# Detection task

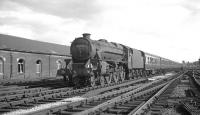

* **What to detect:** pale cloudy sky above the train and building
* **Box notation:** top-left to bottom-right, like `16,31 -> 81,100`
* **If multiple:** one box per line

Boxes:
0,0 -> 200,62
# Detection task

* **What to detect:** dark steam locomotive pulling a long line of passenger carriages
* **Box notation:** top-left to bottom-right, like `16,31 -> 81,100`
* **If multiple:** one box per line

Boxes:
58,33 -> 182,87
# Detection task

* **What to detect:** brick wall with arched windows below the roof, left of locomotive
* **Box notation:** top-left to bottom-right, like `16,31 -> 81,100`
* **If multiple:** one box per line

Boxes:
0,50 -> 69,80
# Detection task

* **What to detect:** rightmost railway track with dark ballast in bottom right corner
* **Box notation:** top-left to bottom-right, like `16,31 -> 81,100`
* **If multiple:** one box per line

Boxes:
144,72 -> 200,115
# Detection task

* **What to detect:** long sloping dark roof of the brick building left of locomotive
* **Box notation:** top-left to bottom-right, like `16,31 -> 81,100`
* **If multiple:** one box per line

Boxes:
0,34 -> 70,55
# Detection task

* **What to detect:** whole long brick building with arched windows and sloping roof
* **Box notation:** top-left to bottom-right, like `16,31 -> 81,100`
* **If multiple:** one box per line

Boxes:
0,34 -> 70,81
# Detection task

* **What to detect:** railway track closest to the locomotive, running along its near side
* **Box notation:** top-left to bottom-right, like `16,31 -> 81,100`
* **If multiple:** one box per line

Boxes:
0,78 -> 150,113
